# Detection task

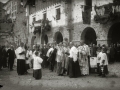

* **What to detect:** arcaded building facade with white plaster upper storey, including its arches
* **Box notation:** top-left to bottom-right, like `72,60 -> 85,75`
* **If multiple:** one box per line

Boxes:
26,0 -> 120,45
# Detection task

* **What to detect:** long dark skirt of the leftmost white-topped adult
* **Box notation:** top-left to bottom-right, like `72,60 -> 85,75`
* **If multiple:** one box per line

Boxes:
17,59 -> 26,75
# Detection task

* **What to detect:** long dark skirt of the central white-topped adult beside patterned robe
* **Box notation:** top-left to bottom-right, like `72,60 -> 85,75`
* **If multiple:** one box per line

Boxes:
68,58 -> 80,78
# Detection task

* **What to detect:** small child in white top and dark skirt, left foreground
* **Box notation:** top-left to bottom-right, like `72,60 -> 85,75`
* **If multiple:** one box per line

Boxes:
33,51 -> 43,80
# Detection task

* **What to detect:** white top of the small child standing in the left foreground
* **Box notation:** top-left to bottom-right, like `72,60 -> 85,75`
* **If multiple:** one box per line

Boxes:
33,56 -> 43,70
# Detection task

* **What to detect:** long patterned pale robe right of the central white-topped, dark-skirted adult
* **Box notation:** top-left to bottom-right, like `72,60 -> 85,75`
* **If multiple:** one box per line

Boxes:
78,46 -> 89,75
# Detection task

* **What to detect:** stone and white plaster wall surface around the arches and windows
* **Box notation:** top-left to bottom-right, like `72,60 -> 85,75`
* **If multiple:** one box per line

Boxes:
29,0 -> 117,45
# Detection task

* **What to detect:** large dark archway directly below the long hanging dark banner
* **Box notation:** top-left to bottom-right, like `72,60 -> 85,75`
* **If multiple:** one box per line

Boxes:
81,27 -> 97,45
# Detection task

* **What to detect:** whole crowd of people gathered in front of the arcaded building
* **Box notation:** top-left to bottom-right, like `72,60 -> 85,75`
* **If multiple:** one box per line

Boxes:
0,40 -> 120,79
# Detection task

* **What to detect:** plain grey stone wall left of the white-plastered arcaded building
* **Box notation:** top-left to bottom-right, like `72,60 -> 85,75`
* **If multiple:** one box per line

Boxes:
14,6 -> 28,43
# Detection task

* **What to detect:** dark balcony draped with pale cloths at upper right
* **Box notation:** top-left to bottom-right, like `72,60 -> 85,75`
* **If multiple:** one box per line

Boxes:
94,3 -> 120,24
